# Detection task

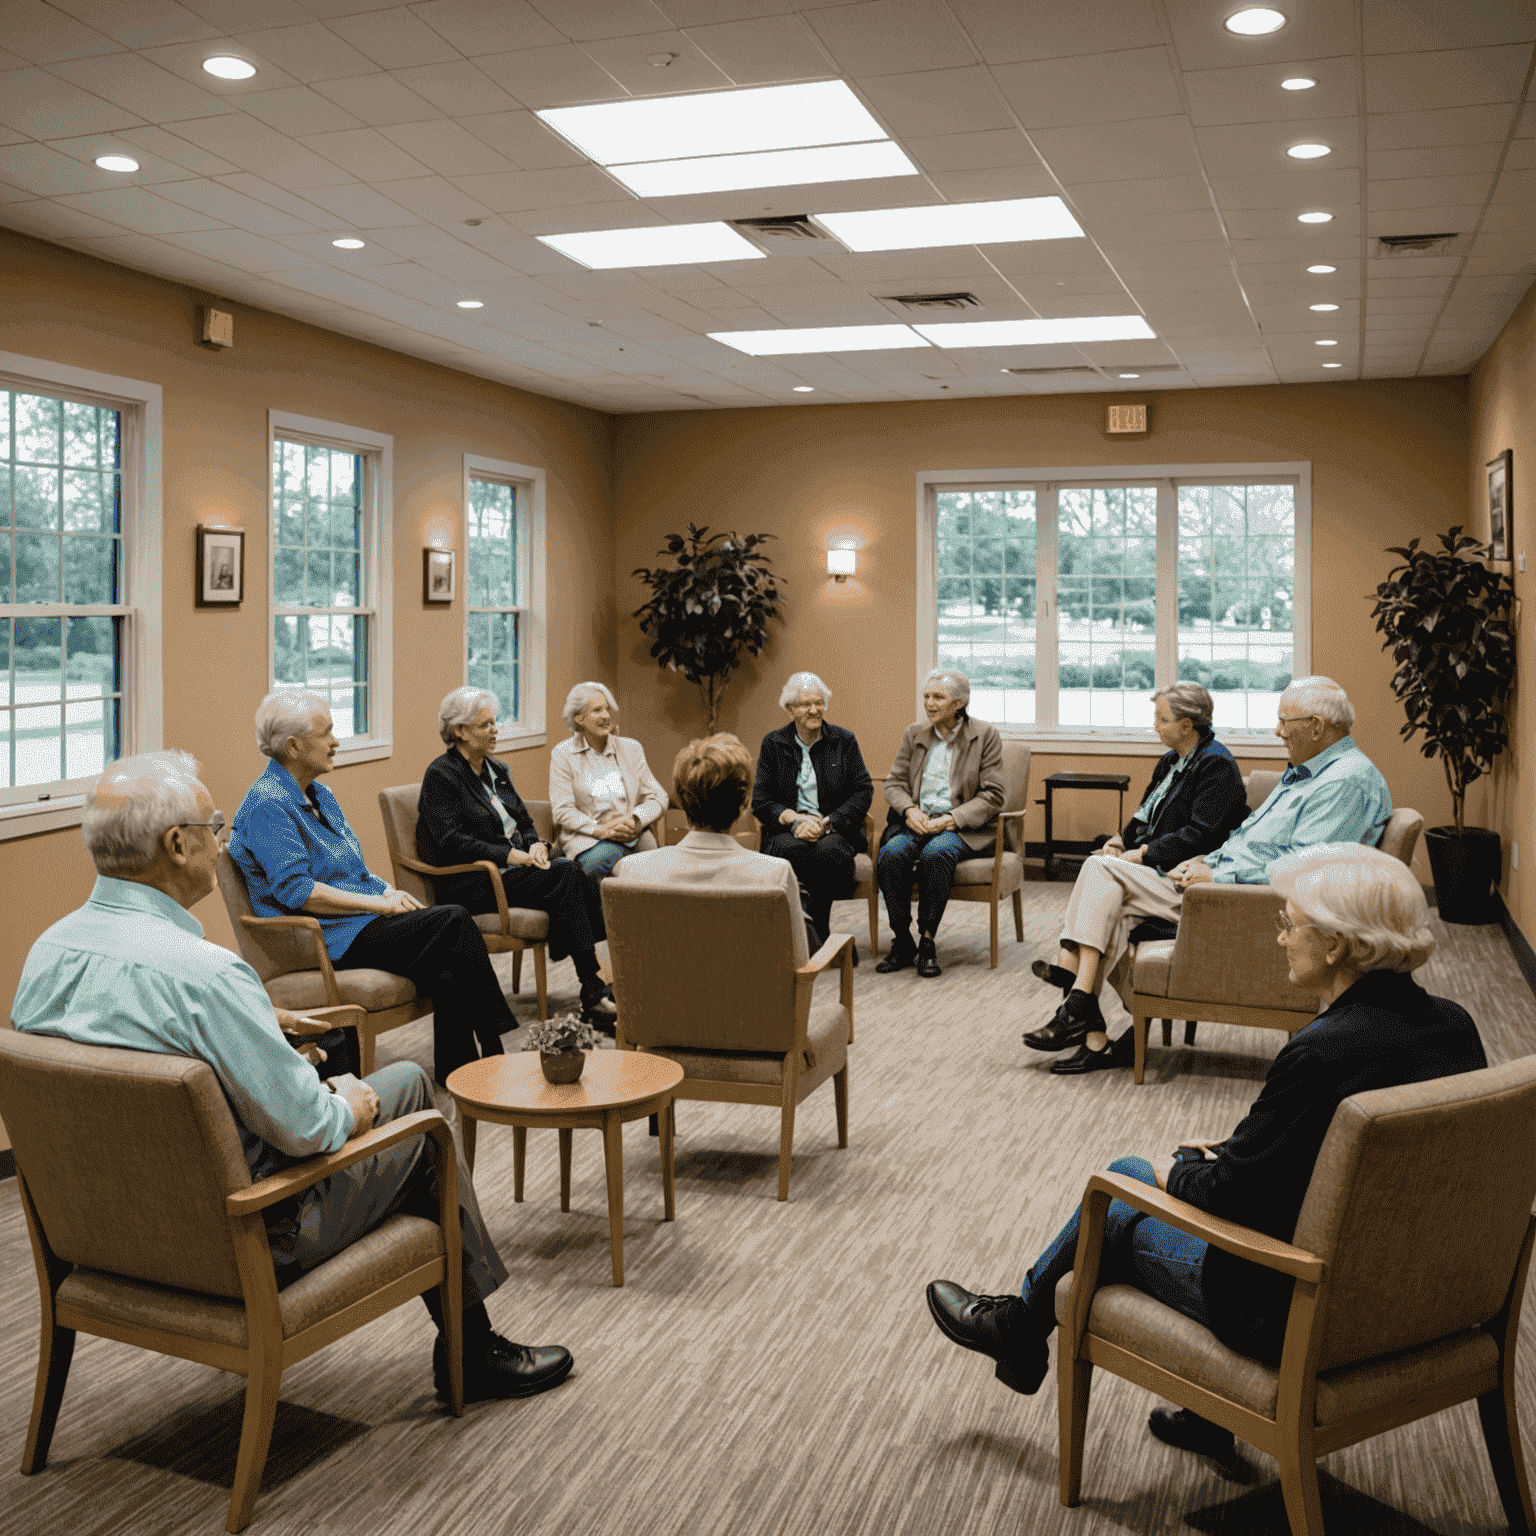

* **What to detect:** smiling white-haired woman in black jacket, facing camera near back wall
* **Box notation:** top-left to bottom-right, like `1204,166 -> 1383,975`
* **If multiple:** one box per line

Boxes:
753,671 -> 874,946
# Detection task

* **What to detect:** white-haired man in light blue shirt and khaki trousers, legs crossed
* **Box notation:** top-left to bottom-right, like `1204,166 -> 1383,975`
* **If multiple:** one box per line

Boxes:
1025,677 -> 1392,1074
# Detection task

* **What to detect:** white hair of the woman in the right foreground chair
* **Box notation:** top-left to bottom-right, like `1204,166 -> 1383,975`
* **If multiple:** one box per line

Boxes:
1269,843 -> 1435,971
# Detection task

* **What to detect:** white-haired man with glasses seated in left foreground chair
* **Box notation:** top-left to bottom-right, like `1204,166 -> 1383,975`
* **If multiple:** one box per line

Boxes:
11,751 -> 571,1401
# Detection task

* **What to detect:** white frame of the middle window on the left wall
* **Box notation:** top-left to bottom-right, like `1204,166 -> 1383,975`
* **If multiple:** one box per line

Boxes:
267,410 -> 395,768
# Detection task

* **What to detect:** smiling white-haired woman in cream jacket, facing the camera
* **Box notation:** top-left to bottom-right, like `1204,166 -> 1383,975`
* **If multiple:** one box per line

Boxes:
550,682 -> 667,886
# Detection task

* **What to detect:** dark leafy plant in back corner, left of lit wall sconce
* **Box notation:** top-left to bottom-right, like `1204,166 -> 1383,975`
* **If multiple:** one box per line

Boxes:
631,522 -> 779,734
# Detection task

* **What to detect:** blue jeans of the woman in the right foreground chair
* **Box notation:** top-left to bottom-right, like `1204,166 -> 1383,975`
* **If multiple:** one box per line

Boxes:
1020,1157 -> 1210,1329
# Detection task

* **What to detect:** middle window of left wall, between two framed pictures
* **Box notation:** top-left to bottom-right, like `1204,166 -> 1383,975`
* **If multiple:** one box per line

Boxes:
270,412 -> 393,763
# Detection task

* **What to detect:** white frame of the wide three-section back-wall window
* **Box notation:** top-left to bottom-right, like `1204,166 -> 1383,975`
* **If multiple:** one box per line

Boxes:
914,461 -> 1312,757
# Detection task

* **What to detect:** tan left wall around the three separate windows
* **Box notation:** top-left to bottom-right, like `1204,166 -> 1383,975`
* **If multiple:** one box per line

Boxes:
0,230 -> 614,1003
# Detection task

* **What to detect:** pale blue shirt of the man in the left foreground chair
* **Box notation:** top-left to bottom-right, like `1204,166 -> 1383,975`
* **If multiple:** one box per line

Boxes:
11,876 -> 353,1178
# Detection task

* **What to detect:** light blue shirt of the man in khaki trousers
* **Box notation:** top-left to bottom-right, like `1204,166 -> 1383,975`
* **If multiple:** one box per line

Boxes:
1206,736 -> 1392,885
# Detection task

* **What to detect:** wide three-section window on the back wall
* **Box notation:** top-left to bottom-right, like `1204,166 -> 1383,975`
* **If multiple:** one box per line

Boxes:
919,464 -> 1310,751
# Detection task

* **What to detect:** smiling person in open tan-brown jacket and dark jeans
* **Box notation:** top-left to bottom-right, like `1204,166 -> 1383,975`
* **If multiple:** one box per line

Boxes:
876,667 -> 1006,977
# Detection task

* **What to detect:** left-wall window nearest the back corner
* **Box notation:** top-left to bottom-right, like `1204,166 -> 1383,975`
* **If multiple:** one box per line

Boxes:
464,453 -> 544,746
